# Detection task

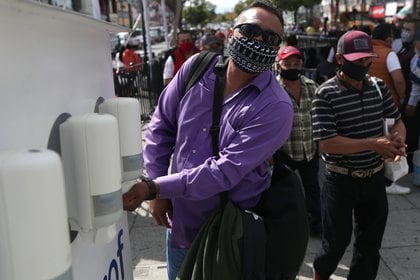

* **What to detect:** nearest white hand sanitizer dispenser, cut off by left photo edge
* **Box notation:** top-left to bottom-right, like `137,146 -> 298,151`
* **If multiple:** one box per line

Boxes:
0,150 -> 73,280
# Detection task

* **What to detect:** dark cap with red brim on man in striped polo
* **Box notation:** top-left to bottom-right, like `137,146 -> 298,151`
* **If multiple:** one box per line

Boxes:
337,30 -> 377,61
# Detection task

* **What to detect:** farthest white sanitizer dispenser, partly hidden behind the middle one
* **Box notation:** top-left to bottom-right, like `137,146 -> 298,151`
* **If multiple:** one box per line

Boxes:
99,97 -> 143,192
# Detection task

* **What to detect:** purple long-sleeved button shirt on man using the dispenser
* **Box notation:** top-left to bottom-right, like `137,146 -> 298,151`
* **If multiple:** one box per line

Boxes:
144,54 -> 293,248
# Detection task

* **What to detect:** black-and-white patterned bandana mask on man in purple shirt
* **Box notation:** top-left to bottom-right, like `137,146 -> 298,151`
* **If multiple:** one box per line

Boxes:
228,36 -> 277,73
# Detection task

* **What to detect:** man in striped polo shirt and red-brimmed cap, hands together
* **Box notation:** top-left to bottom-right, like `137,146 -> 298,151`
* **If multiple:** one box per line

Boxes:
312,30 -> 406,280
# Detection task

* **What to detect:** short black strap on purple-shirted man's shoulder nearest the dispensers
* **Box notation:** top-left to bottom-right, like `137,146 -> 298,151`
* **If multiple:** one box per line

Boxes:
183,51 -> 218,94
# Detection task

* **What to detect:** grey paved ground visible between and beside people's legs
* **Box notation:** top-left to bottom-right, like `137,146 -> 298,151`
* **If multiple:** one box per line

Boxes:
129,123 -> 420,280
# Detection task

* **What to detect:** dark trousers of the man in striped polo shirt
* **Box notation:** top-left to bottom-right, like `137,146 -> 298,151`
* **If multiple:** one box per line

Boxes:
314,171 -> 388,280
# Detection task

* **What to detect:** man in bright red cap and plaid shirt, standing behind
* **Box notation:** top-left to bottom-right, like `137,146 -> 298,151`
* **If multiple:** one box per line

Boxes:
277,46 -> 322,237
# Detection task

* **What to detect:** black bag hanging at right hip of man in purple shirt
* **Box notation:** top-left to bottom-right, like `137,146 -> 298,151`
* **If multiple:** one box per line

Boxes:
253,151 -> 309,280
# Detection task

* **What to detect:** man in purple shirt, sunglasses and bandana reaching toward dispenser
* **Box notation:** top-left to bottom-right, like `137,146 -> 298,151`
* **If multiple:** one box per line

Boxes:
123,1 -> 293,280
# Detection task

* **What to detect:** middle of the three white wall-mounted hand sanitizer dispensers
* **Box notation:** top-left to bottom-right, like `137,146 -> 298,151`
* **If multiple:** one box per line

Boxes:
60,113 -> 123,243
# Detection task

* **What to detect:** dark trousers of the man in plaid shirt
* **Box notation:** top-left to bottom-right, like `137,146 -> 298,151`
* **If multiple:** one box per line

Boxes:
296,154 -> 321,232
